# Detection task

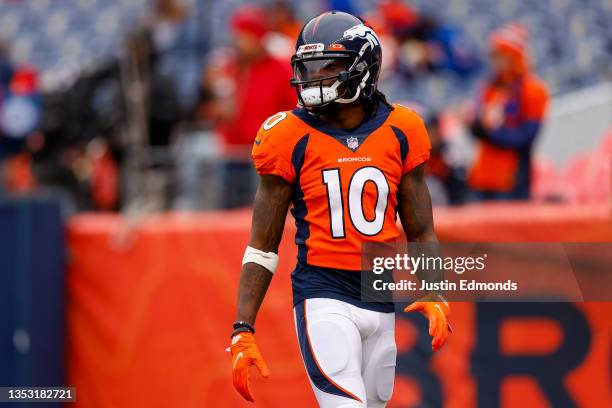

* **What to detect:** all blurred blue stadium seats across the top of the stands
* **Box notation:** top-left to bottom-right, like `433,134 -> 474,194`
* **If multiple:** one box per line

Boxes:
0,0 -> 612,103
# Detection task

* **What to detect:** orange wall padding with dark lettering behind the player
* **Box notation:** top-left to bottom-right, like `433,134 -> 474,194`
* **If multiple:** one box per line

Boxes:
67,204 -> 612,408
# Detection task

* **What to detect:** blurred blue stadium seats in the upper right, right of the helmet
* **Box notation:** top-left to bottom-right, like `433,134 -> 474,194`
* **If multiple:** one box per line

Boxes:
382,0 -> 612,108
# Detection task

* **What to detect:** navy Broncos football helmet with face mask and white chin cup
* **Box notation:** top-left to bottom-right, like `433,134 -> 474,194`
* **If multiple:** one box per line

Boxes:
291,11 -> 382,109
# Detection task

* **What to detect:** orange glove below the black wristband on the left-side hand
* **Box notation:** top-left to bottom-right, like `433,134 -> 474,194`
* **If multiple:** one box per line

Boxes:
229,332 -> 270,402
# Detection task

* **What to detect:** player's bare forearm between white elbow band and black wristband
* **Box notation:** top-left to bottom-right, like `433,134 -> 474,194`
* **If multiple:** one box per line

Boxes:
236,263 -> 273,324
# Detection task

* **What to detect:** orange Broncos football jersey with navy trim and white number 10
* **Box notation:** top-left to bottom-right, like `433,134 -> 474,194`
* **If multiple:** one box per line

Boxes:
252,103 -> 431,271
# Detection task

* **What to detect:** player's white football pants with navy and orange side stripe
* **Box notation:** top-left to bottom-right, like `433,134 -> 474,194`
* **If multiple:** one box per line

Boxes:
294,298 -> 397,408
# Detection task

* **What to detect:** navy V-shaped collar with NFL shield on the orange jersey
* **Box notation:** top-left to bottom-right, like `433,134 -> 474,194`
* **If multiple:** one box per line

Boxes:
293,102 -> 391,151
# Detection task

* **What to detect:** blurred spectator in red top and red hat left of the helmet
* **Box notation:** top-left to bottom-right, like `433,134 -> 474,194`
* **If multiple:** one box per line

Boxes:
200,6 -> 296,208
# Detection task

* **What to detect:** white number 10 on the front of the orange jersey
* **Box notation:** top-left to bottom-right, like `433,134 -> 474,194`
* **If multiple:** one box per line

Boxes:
322,167 -> 389,238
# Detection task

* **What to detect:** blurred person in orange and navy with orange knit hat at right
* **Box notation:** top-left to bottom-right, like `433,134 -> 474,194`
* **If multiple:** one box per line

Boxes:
469,24 -> 548,200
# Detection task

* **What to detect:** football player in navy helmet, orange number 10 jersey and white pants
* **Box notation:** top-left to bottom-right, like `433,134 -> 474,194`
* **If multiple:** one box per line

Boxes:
230,11 -> 450,408
